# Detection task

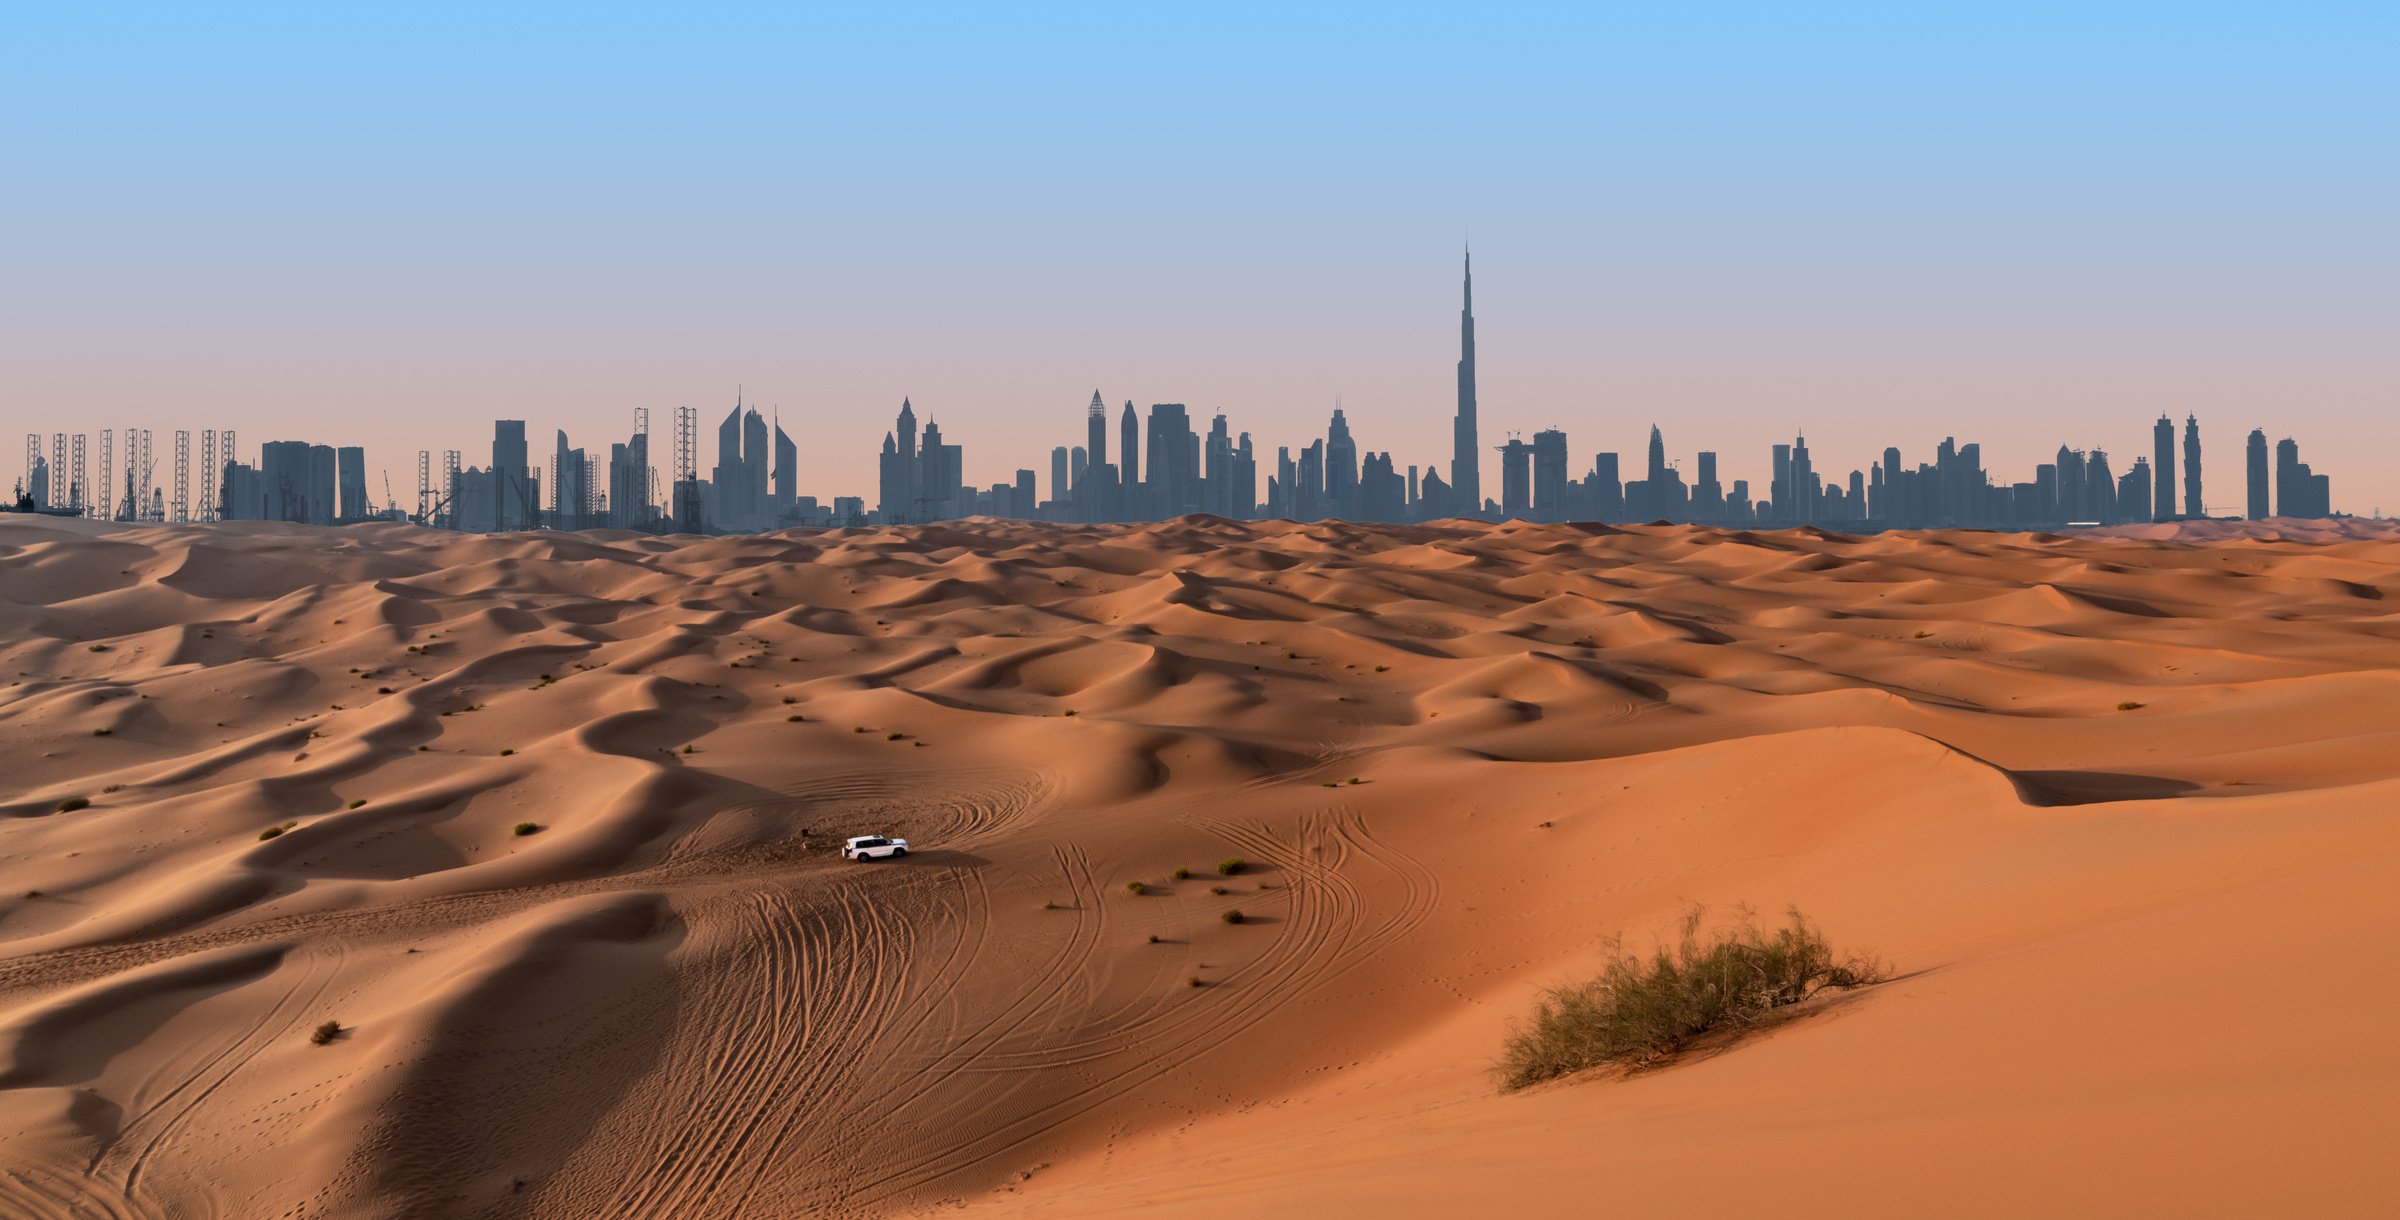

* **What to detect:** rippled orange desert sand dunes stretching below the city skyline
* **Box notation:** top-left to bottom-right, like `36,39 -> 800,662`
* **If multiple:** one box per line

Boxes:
0,516 -> 2400,1218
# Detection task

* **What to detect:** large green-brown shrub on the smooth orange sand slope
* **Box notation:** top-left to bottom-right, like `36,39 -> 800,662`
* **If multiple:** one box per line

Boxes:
1498,910 -> 1884,1088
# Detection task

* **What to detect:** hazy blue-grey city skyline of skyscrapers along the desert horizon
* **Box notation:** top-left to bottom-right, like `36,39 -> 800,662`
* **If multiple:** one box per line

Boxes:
17,249 -> 2361,533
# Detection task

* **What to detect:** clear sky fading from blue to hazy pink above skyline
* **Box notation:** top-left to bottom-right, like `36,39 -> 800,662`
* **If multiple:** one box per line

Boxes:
0,0 -> 2400,514
